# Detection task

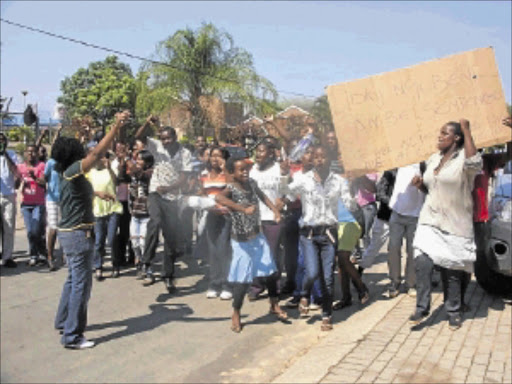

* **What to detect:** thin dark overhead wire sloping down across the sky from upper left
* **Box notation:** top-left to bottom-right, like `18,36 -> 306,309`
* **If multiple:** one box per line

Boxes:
0,18 -> 318,99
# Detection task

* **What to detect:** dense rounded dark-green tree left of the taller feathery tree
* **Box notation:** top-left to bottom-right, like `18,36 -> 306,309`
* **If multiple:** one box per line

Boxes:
58,56 -> 136,126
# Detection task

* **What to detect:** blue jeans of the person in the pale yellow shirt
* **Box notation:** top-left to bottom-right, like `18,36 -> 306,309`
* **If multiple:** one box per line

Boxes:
94,213 -> 120,269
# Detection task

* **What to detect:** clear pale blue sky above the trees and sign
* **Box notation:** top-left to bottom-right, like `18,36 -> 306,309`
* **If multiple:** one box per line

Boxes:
0,0 -> 512,118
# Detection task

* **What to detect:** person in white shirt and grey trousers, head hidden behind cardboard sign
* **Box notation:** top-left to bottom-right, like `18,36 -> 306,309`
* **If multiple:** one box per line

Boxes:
388,164 -> 425,298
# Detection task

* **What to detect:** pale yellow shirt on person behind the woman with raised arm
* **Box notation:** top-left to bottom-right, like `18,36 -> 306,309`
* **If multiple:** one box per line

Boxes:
86,168 -> 123,217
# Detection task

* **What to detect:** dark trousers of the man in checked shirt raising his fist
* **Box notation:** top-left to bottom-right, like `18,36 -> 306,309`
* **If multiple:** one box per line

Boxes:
142,192 -> 180,278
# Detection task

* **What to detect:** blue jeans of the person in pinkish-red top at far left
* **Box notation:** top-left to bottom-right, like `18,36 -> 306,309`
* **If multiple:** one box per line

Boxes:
21,204 -> 46,257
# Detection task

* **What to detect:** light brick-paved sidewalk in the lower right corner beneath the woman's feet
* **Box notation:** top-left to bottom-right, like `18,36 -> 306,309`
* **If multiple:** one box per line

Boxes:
320,281 -> 512,383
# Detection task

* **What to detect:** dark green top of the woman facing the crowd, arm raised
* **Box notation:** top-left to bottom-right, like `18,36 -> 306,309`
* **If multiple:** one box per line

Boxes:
59,161 -> 94,231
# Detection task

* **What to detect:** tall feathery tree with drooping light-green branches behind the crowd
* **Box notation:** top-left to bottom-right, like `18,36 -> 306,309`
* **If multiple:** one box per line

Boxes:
138,23 -> 277,133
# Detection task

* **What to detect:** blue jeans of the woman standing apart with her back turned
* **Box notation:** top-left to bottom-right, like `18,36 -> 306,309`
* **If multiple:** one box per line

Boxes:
55,230 -> 93,345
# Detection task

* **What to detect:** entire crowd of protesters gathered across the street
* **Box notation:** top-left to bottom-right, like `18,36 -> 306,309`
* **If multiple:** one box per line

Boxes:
0,111 -> 510,349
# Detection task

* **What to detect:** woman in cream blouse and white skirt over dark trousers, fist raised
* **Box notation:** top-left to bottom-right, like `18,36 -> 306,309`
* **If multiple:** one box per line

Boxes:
409,119 -> 482,330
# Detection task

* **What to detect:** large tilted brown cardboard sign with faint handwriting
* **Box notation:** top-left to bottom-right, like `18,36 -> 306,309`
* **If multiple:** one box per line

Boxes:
327,48 -> 511,174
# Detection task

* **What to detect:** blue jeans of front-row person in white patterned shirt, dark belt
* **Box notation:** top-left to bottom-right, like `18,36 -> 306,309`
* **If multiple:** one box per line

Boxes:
300,234 -> 336,317
